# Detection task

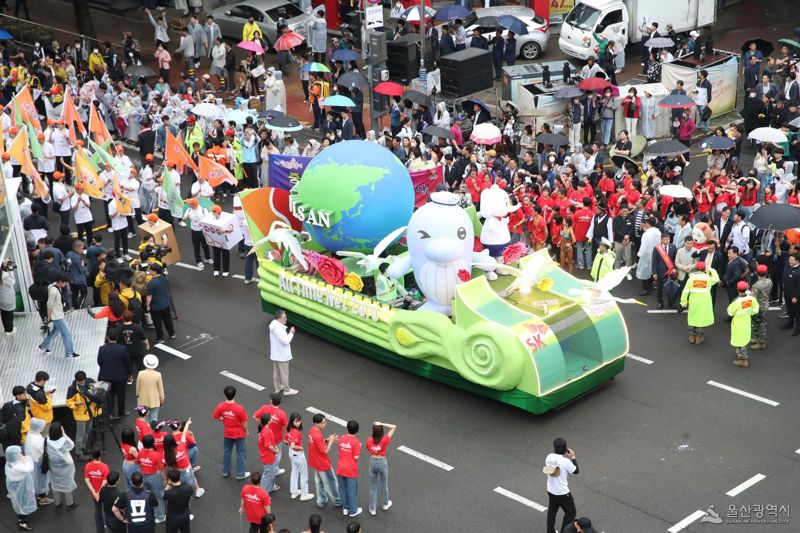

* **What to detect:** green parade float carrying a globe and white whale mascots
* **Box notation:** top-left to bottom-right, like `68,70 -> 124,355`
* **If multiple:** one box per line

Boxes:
240,141 -> 628,414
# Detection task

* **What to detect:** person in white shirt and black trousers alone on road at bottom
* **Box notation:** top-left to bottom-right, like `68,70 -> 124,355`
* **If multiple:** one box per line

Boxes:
542,437 -> 578,533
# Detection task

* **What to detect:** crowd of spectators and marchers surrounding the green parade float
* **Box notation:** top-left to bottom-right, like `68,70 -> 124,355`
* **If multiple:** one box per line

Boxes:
0,1 -> 800,533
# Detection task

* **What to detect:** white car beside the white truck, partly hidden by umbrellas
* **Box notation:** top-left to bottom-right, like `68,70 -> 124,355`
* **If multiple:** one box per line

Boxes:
464,6 -> 550,59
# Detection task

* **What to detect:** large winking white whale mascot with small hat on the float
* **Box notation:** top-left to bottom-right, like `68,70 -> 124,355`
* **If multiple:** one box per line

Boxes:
386,191 -> 494,316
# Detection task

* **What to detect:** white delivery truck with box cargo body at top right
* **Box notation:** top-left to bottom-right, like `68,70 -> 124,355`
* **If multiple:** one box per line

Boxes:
558,0 -> 717,59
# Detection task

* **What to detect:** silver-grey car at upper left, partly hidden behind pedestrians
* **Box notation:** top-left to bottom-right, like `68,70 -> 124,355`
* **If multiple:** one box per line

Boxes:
211,0 -> 311,43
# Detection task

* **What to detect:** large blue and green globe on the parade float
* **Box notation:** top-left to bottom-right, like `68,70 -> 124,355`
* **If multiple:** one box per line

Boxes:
290,141 -> 414,252
